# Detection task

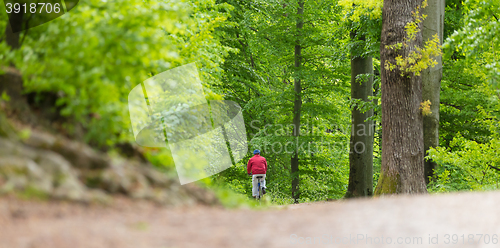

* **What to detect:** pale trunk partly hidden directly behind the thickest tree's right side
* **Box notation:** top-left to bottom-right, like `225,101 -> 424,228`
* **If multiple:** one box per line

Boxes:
422,0 -> 445,183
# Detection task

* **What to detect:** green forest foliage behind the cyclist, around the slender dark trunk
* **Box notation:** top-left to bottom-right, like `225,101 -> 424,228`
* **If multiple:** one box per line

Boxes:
212,0 -> 350,204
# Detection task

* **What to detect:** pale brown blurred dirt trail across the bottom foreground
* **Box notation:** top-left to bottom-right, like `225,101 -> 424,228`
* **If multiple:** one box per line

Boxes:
0,192 -> 500,248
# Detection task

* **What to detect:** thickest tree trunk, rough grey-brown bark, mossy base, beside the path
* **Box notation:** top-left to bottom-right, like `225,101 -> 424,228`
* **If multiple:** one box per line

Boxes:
375,0 -> 427,195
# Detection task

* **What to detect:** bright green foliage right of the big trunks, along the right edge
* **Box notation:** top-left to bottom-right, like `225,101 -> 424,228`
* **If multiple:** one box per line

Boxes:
428,7 -> 500,192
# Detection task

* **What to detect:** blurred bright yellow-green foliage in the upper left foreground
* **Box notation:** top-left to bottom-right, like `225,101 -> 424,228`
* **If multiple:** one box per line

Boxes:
0,0 -> 229,145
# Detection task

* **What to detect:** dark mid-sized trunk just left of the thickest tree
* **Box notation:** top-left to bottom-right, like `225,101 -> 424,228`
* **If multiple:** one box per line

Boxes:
345,33 -> 374,198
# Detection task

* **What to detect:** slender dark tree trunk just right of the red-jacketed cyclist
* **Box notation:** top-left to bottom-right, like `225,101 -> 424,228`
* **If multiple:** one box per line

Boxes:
290,0 -> 304,203
